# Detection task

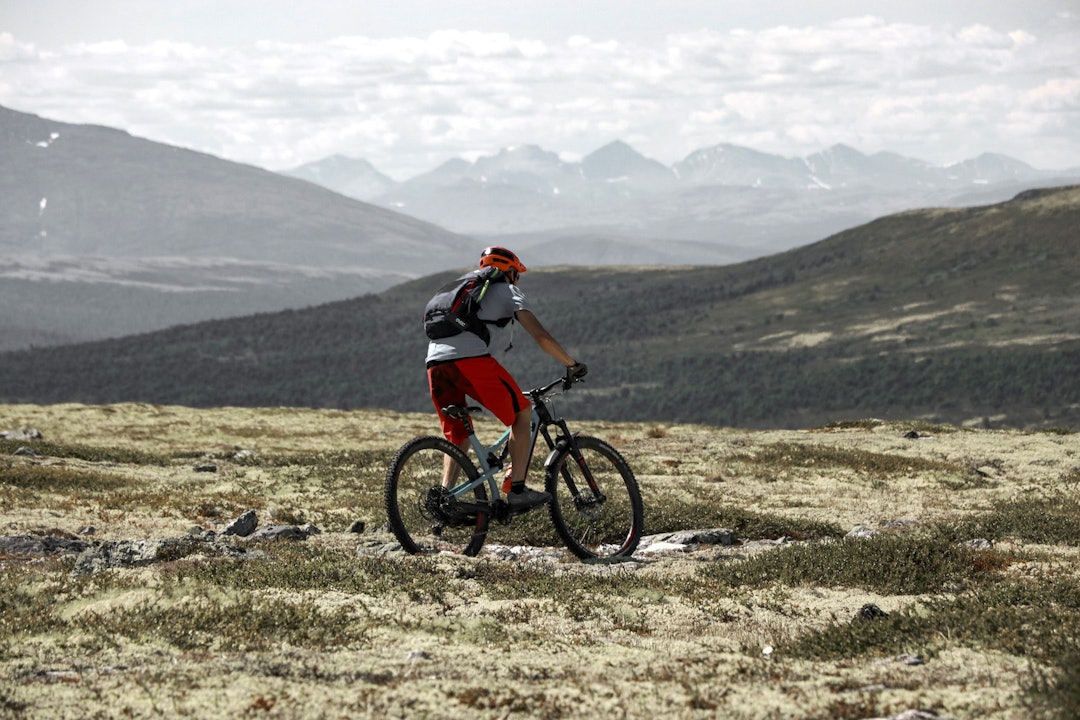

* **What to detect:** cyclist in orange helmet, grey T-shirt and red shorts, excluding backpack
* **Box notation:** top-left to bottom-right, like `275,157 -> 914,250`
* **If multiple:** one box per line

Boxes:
427,247 -> 588,511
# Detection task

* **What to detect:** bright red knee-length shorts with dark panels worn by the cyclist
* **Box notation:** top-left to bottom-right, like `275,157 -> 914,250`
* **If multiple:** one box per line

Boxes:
428,355 -> 529,445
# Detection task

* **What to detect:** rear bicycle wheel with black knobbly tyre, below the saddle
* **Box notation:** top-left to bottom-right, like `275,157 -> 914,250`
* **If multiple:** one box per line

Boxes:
383,436 -> 490,555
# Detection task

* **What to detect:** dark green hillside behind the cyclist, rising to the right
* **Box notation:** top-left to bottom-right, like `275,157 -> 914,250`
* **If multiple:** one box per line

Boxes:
0,187 -> 1080,427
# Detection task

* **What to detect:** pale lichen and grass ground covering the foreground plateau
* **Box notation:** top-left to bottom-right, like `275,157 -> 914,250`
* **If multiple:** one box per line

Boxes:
0,406 -> 1080,719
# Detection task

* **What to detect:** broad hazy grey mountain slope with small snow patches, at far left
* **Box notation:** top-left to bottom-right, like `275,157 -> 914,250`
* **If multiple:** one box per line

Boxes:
0,107 -> 477,350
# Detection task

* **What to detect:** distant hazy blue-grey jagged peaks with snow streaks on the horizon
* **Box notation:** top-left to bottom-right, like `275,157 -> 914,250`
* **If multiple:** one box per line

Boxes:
287,141 -> 1080,255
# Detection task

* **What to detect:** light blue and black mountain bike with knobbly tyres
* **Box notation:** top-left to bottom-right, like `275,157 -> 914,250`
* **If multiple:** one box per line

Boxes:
383,377 -> 644,559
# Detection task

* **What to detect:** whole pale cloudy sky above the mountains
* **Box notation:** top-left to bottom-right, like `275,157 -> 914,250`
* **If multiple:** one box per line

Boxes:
0,0 -> 1080,180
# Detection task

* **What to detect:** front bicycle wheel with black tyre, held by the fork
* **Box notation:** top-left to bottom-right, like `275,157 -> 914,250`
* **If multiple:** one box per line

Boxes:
544,436 -> 645,559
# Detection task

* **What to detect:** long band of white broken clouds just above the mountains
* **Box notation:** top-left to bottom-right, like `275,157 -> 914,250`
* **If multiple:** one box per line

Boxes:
0,16 -> 1080,179
